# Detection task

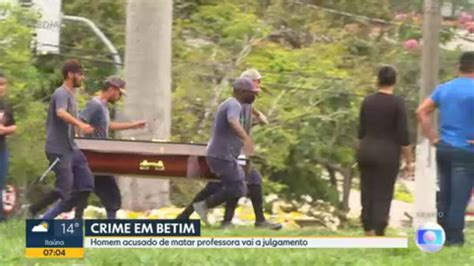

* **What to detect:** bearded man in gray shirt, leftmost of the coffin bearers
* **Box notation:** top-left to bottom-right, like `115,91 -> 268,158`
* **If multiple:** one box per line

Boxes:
29,60 -> 94,219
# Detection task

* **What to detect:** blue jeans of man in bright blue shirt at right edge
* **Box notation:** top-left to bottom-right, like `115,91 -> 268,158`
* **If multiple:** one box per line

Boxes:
436,142 -> 474,244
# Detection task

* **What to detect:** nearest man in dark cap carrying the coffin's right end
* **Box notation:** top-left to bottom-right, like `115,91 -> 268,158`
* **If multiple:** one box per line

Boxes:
193,78 -> 258,224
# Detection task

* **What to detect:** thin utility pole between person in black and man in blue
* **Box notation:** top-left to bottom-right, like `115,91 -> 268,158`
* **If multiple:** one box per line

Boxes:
413,0 -> 441,228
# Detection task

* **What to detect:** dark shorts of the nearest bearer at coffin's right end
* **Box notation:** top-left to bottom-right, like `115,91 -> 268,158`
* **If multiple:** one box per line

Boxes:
207,157 -> 247,197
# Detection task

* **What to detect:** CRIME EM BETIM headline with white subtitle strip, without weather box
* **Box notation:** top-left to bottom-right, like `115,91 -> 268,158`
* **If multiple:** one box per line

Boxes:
84,220 -> 408,248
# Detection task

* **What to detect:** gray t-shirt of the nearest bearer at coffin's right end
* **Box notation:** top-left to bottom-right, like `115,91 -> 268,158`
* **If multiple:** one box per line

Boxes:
207,97 -> 242,161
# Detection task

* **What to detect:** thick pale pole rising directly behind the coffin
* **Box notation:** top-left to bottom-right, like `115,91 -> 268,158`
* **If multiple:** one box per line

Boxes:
119,0 -> 172,211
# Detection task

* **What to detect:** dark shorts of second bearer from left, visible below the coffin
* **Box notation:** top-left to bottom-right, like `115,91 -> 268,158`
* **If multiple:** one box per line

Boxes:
94,176 -> 122,211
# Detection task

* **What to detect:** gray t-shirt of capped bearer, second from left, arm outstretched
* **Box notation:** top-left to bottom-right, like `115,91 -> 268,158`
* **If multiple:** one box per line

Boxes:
79,97 -> 110,139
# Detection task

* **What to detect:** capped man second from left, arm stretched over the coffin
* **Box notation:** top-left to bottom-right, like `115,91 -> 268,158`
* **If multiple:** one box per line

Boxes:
75,76 -> 146,219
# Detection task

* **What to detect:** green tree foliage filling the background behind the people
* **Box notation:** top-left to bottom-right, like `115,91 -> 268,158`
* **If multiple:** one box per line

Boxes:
0,0 -> 466,210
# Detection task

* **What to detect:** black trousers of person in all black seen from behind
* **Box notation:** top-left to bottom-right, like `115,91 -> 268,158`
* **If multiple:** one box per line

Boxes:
358,140 -> 400,236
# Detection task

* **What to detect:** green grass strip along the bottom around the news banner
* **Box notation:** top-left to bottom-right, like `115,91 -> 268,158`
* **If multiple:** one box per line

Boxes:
0,220 -> 474,266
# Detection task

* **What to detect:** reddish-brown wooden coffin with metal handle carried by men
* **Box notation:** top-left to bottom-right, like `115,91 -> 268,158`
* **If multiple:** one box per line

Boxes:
76,138 -> 217,181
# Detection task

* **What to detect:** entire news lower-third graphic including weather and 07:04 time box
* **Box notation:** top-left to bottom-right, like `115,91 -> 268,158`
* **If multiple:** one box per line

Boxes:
26,220 -> 408,251
